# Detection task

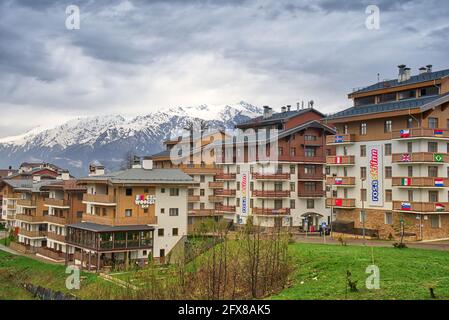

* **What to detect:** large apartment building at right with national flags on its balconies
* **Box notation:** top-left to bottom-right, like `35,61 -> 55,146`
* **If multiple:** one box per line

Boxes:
326,65 -> 449,240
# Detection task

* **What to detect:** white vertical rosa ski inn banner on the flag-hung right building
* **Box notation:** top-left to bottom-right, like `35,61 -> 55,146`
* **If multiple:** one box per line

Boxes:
367,145 -> 383,207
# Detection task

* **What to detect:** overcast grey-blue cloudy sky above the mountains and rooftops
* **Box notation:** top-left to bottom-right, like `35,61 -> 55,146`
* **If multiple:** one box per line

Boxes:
0,0 -> 449,137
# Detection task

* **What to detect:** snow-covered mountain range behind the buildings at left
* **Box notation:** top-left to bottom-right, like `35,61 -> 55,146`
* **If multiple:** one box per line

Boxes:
0,101 -> 263,176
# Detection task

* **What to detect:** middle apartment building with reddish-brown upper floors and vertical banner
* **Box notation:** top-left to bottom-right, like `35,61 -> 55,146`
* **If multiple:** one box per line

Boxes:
214,105 -> 335,231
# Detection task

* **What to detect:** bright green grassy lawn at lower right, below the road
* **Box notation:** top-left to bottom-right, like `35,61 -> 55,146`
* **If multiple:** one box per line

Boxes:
272,244 -> 449,300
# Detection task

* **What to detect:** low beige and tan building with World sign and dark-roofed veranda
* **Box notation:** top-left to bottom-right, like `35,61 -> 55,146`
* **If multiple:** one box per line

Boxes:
66,159 -> 195,269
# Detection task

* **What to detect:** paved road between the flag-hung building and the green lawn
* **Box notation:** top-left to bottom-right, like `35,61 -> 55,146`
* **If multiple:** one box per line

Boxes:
293,235 -> 449,251
